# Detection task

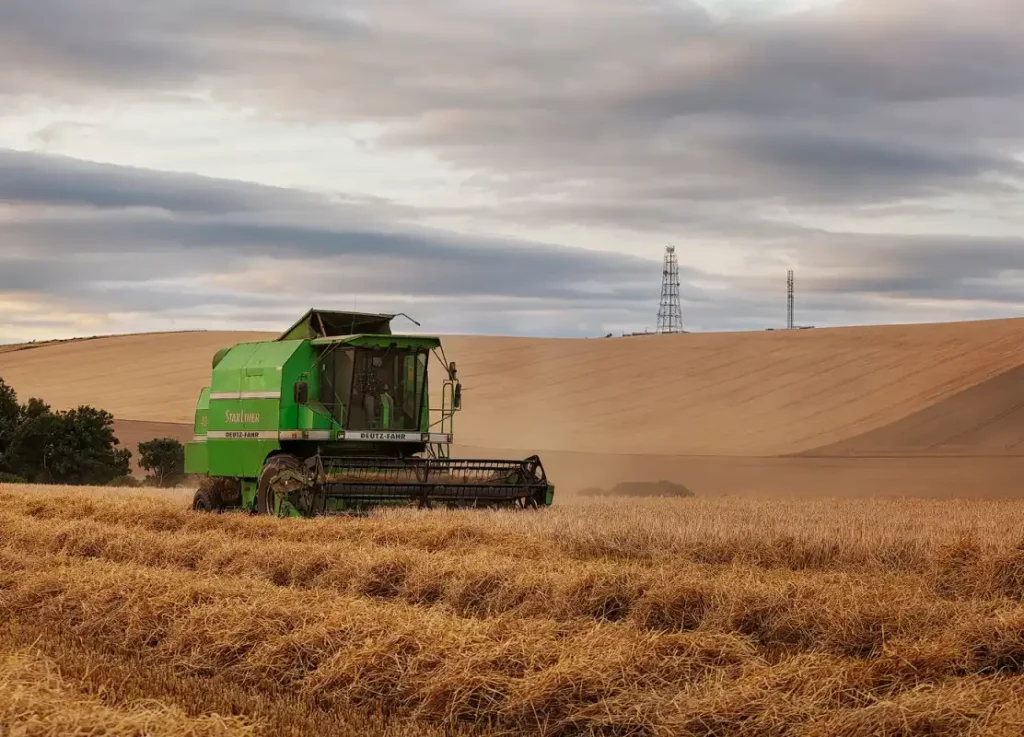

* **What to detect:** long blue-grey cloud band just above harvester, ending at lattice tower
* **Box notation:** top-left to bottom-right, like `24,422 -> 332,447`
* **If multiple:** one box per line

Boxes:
0,211 -> 660,299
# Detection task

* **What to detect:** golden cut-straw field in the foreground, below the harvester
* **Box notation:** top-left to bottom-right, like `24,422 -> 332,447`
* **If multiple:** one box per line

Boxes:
8,485 -> 1024,737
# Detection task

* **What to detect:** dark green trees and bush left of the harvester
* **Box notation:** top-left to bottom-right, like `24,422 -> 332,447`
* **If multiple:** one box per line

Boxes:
0,378 -> 184,486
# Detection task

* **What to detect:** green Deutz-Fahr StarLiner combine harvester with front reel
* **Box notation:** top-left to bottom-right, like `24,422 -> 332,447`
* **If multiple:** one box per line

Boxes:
185,309 -> 554,517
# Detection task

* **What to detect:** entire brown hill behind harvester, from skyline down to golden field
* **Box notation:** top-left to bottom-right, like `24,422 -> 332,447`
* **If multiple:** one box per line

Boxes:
0,319 -> 1024,501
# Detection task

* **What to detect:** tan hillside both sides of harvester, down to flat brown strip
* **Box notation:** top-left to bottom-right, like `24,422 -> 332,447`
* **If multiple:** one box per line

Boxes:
0,319 -> 1024,456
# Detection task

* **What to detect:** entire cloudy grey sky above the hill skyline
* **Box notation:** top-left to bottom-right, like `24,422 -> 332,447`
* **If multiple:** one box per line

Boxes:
0,0 -> 1024,342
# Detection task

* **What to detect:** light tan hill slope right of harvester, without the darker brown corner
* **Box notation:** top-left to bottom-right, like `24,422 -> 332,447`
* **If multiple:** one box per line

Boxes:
449,319 -> 1024,456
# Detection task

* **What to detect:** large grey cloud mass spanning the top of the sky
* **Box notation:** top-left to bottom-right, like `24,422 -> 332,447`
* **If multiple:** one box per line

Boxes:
8,0 -> 1024,215
